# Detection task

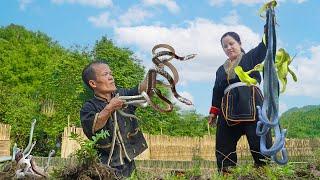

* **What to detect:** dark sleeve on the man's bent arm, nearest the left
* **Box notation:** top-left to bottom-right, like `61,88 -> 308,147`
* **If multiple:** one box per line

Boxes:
80,102 -> 99,139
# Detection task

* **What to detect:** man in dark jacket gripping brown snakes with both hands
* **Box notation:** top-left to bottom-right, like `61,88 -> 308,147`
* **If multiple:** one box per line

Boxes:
80,61 -> 147,177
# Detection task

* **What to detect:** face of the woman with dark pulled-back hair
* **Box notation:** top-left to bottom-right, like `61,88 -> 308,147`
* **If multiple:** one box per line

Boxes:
222,35 -> 241,60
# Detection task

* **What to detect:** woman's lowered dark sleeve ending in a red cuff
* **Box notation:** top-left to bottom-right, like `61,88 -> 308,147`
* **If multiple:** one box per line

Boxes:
209,70 -> 224,115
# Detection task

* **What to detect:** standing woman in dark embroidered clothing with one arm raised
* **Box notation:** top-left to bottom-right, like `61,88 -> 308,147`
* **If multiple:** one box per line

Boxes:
209,32 -> 271,172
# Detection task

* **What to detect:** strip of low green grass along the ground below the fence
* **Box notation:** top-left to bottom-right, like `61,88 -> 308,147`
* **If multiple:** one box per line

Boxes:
0,150 -> 320,180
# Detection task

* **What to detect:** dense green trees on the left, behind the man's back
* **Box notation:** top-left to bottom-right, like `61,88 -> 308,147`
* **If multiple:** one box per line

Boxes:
0,24 -> 88,155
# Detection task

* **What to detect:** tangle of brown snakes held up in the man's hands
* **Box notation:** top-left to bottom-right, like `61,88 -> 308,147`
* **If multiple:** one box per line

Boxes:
119,44 -> 196,113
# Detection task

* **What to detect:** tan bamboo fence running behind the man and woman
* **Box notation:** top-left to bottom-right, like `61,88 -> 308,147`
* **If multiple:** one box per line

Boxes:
0,123 -> 320,171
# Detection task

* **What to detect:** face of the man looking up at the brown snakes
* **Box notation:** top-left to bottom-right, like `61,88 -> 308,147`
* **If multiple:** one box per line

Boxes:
89,64 -> 117,94
